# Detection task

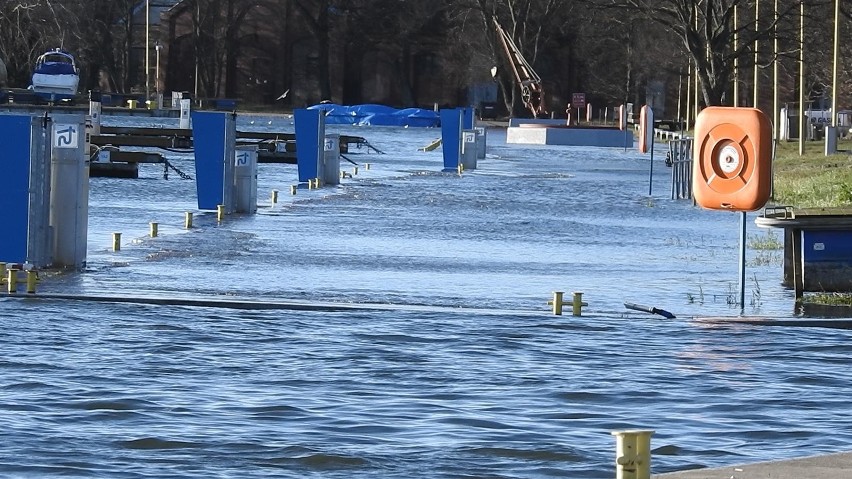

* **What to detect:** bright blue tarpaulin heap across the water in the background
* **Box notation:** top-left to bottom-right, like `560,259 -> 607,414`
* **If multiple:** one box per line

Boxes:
308,103 -> 441,128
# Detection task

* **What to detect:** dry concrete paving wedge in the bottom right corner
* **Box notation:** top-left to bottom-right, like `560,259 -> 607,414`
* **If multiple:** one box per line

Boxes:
651,452 -> 852,479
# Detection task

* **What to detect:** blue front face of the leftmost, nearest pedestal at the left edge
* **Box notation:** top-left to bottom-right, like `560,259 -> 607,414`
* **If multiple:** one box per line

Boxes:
0,115 -> 32,263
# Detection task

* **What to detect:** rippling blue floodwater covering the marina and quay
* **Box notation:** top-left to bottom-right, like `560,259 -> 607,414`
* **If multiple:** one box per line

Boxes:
0,115 -> 852,478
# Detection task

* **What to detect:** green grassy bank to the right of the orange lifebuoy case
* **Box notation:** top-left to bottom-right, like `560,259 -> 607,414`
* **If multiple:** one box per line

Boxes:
772,140 -> 852,208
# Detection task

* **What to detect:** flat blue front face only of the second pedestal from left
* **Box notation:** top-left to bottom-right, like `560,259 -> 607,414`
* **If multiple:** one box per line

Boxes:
192,111 -> 226,210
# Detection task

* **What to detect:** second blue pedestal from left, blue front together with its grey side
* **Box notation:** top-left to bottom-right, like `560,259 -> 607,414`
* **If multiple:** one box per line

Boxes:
192,111 -> 237,214
